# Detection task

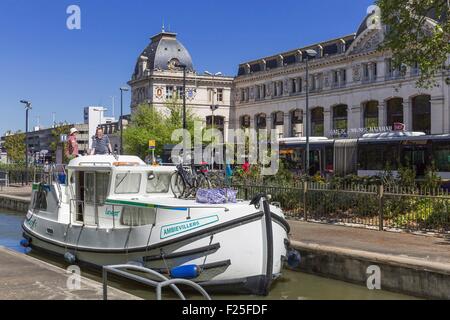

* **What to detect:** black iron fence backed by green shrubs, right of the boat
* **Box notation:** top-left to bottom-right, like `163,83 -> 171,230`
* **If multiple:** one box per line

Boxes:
233,182 -> 450,233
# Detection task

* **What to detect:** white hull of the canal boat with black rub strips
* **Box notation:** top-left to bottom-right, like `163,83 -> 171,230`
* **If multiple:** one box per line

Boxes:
23,210 -> 289,295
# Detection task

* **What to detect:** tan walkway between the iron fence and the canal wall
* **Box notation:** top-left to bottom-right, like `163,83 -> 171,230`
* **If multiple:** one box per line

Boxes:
289,220 -> 450,270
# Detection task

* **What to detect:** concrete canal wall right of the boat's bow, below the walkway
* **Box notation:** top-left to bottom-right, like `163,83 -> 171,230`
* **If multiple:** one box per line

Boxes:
291,241 -> 450,299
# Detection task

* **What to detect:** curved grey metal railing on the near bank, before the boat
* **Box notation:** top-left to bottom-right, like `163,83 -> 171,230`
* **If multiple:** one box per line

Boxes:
102,264 -> 211,300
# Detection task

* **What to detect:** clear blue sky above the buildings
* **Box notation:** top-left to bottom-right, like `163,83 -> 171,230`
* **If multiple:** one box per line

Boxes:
0,0 -> 373,134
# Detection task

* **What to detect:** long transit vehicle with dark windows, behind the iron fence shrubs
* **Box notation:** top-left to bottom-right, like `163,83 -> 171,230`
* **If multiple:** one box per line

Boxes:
279,131 -> 450,180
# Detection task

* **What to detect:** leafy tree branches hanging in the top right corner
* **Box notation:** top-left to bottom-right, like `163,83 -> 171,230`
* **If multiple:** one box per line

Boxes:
376,0 -> 450,88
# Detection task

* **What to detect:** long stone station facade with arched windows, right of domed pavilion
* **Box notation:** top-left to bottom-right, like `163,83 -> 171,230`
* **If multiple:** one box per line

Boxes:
233,16 -> 450,137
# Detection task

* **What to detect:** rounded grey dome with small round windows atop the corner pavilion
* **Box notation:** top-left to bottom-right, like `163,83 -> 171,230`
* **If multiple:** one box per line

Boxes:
134,31 -> 194,76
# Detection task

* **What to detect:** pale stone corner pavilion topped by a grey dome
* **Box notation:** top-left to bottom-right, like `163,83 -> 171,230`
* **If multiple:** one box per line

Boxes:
128,30 -> 234,138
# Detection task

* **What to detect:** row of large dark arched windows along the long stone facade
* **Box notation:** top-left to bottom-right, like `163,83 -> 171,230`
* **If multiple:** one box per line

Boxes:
240,95 -> 431,136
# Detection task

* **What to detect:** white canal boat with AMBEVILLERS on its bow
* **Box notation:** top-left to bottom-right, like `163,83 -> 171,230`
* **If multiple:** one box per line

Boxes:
22,155 -> 289,295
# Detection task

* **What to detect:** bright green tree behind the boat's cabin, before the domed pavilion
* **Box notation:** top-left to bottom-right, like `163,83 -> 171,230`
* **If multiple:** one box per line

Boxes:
123,100 -> 198,158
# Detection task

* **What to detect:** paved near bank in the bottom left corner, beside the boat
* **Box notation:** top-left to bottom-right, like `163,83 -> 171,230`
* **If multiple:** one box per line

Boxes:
0,247 -> 139,300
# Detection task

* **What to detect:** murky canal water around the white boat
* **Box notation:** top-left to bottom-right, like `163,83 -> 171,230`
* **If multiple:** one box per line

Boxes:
0,210 -> 415,300
